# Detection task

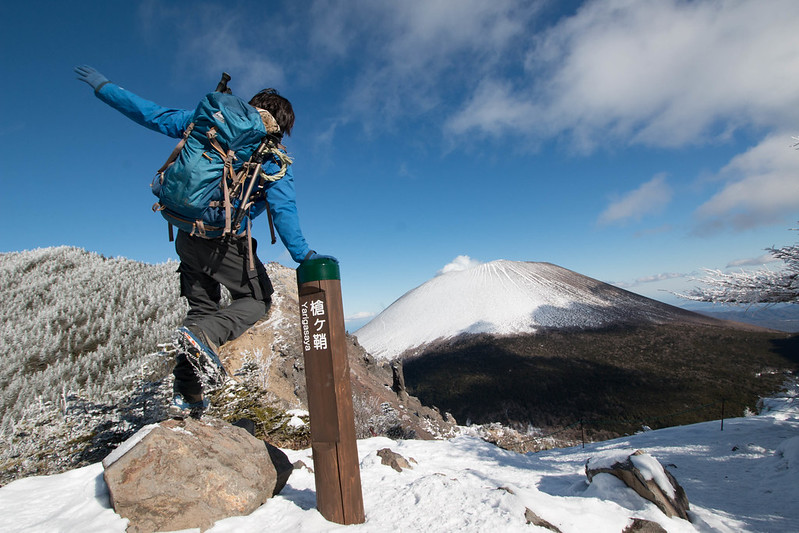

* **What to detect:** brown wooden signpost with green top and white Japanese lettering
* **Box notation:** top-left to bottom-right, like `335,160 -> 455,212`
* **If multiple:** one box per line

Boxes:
297,259 -> 366,524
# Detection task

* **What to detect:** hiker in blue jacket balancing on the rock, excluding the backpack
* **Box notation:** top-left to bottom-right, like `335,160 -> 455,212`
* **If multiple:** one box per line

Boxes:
75,66 -> 335,418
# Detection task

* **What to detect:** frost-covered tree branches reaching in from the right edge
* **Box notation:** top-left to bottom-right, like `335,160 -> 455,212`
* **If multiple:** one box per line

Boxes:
680,230 -> 799,304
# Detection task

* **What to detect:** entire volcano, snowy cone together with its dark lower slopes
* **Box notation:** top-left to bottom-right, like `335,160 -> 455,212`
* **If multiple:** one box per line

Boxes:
355,261 -> 799,438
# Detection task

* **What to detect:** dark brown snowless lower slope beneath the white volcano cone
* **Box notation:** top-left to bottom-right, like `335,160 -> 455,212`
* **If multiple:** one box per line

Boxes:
405,315 -> 799,444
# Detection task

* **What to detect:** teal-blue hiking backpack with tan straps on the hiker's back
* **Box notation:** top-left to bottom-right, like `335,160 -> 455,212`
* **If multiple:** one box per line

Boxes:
152,76 -> 291,255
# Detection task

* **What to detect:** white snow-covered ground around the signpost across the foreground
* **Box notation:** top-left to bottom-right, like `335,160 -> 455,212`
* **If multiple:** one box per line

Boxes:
0,384 -> 799,533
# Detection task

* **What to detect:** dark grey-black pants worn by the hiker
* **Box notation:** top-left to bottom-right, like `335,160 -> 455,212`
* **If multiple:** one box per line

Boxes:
173,231 -> 274,401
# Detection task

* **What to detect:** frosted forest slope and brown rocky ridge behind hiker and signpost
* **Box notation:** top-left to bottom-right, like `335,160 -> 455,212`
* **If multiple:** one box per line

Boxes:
0,246 -> 452,485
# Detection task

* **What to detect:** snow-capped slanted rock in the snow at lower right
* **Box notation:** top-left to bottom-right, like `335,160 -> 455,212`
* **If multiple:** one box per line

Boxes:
585,450 -> 689,520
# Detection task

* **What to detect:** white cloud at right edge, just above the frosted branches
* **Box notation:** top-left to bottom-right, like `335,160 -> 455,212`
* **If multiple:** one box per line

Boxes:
696,133 -> 799,233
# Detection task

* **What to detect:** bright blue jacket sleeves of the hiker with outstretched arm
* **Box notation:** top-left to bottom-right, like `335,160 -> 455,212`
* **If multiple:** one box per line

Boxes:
94,83 -> 310,263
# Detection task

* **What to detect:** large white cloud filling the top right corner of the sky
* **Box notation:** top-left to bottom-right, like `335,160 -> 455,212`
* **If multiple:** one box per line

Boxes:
447,0 -> 799,151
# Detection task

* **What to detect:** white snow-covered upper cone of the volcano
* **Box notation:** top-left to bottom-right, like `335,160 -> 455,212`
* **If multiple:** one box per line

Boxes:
355,260 -> 716,359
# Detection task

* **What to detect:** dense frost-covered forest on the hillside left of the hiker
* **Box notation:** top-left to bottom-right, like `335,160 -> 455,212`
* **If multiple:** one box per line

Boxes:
0,246 -> 186,482
